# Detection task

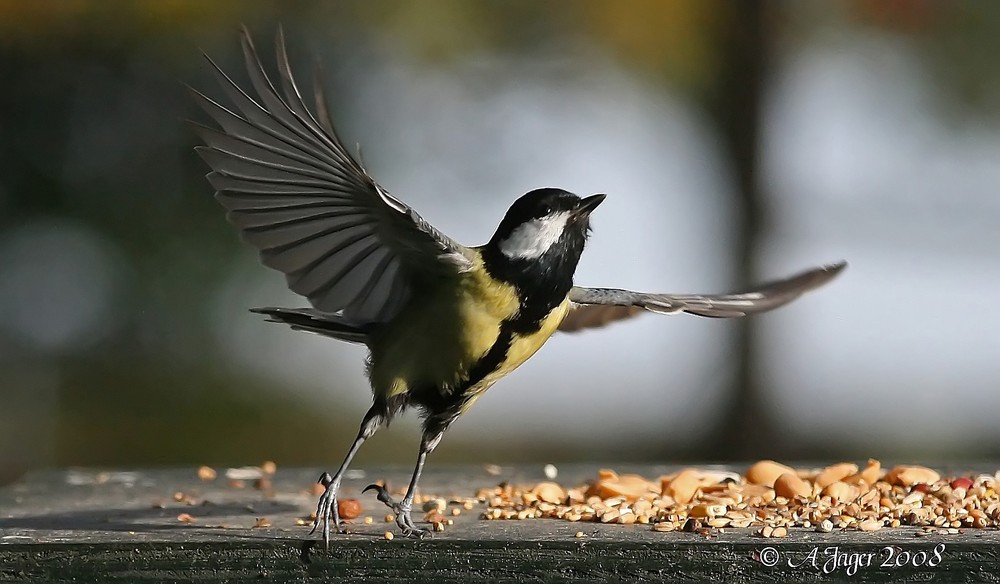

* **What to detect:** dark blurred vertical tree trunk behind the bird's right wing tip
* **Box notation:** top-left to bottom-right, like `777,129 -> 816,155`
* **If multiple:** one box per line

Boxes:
706,0 -> 779,460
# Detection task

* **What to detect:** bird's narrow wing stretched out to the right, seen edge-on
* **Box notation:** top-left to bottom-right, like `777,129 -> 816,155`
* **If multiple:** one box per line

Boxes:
559,262 -> 847,332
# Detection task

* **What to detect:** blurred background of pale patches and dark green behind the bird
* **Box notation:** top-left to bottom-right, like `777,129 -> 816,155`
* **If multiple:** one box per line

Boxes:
0,0 -> 1000,484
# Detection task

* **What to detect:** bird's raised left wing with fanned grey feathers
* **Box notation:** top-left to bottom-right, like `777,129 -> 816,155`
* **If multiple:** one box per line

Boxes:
192,28 -> 471,324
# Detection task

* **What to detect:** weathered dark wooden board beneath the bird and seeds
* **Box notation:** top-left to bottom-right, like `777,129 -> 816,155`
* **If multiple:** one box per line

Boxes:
0,465 -> 1000,582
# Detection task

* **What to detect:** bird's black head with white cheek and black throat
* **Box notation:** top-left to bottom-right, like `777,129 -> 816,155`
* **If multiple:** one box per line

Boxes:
480,189 -> 604,330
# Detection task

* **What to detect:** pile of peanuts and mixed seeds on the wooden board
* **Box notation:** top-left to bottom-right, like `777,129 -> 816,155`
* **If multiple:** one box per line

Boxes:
477,460 -> 1000,537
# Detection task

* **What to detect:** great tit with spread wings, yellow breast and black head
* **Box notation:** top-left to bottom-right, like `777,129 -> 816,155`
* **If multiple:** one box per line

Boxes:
192,29 -> 845,542
